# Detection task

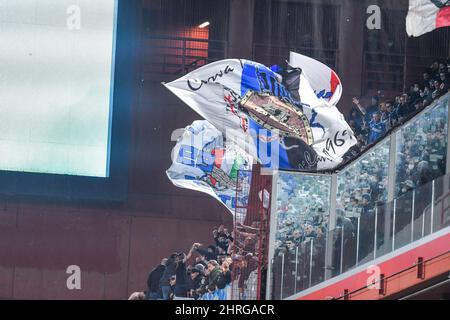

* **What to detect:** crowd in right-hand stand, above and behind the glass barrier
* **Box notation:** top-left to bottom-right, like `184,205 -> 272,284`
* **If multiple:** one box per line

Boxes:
275,61 -> 450,295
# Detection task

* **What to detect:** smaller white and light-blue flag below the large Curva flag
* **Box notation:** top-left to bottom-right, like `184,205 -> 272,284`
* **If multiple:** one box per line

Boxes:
166,120 -> 253,214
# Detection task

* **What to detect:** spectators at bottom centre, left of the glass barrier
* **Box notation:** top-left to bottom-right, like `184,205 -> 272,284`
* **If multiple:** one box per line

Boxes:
129,223 -> 259,300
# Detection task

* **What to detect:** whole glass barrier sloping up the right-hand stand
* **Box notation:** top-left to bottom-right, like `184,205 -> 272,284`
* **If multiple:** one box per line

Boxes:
271,94 -> 450,298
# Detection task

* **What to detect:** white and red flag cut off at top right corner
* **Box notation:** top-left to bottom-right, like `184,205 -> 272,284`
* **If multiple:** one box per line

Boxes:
406,0 -> 450,37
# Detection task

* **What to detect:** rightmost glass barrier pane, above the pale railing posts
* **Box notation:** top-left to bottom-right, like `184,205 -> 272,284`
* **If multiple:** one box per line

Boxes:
395,98 -> 448,196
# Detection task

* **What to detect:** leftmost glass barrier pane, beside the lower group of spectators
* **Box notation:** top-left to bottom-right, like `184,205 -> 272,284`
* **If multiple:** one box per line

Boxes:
272,172 -> 331,298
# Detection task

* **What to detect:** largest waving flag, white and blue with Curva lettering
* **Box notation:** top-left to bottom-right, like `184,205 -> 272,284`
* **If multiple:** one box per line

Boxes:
165,59 -> 356,171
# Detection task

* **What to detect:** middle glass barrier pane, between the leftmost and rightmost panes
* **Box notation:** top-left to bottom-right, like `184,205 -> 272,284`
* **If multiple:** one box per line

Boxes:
336,139 -> 390,272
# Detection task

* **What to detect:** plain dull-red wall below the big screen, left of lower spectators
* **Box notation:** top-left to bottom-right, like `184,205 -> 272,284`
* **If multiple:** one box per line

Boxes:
0,199 -> 232,299
